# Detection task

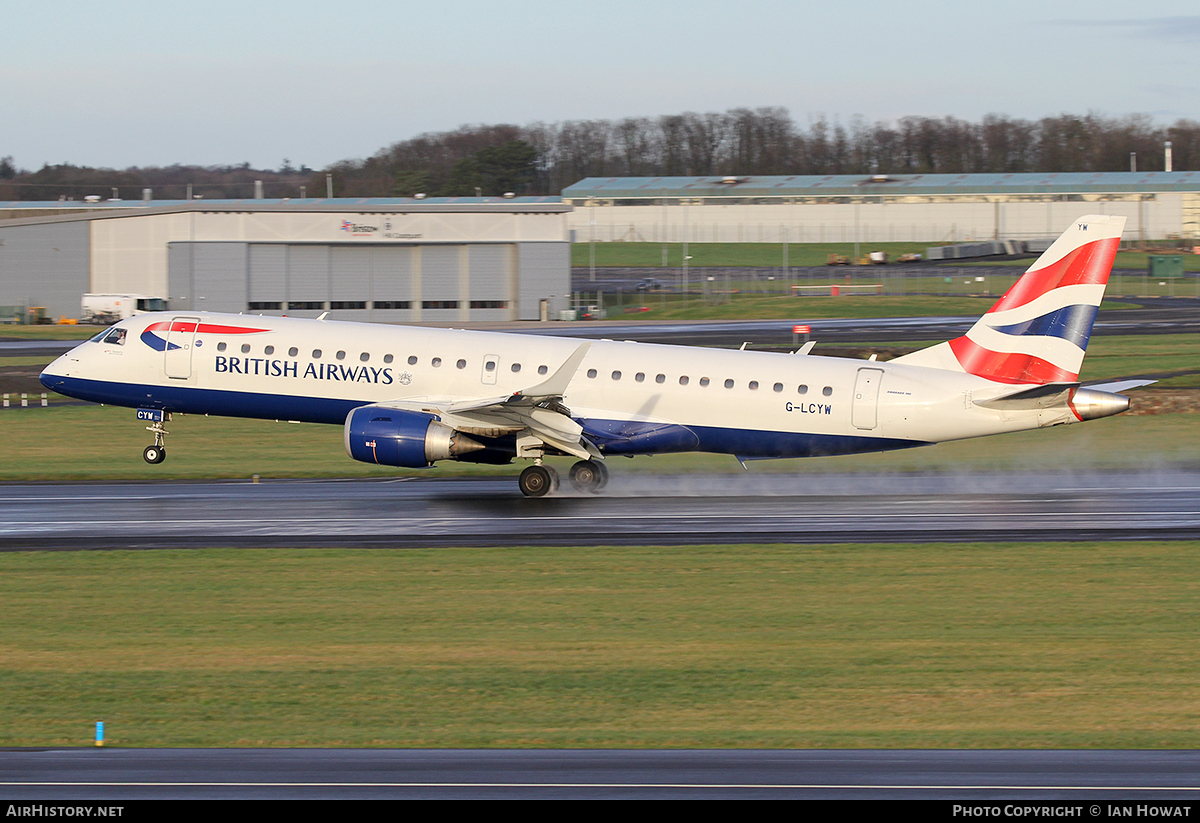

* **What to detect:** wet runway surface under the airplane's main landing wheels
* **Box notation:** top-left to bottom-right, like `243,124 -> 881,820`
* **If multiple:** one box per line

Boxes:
0,464 -> 1200,551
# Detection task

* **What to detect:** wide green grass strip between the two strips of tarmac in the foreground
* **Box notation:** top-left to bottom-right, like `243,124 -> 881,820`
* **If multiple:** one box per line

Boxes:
0,542 -> 1200,749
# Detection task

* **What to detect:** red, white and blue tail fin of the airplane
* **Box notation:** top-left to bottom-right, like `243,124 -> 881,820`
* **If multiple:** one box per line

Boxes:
892,215 -> 1126,384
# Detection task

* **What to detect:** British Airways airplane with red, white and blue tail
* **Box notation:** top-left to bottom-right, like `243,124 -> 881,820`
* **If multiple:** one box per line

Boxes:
41,215 -> 1147,497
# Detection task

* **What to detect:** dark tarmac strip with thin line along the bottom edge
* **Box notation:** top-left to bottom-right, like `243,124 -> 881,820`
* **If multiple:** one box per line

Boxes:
0,749 -> 1200,801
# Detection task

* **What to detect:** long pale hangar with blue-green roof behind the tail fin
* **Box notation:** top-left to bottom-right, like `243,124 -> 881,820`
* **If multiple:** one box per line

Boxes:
563,172 -> 1200,244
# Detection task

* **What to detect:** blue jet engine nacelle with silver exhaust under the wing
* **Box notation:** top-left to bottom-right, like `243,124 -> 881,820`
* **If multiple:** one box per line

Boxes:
346,406 -> 484,469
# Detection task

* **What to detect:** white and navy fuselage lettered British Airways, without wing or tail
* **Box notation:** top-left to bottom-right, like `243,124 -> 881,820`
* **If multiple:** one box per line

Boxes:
43,312 -> 1078,465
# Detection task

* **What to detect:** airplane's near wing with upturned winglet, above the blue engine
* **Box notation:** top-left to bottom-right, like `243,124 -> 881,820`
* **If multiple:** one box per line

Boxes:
369,342 -> 604,459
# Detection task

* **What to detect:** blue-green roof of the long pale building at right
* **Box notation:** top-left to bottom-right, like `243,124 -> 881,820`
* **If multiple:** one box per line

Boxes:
563,172 -> 1200,199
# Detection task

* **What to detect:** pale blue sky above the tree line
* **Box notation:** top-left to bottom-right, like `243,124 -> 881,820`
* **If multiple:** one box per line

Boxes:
0,0 -> 1200,168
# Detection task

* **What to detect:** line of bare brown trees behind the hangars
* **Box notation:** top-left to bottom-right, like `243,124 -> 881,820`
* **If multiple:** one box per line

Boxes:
0,107 -> 1200,200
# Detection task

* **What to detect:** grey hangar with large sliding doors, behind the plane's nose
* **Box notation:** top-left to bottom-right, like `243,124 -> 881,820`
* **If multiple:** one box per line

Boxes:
0,197 -> 571,323
